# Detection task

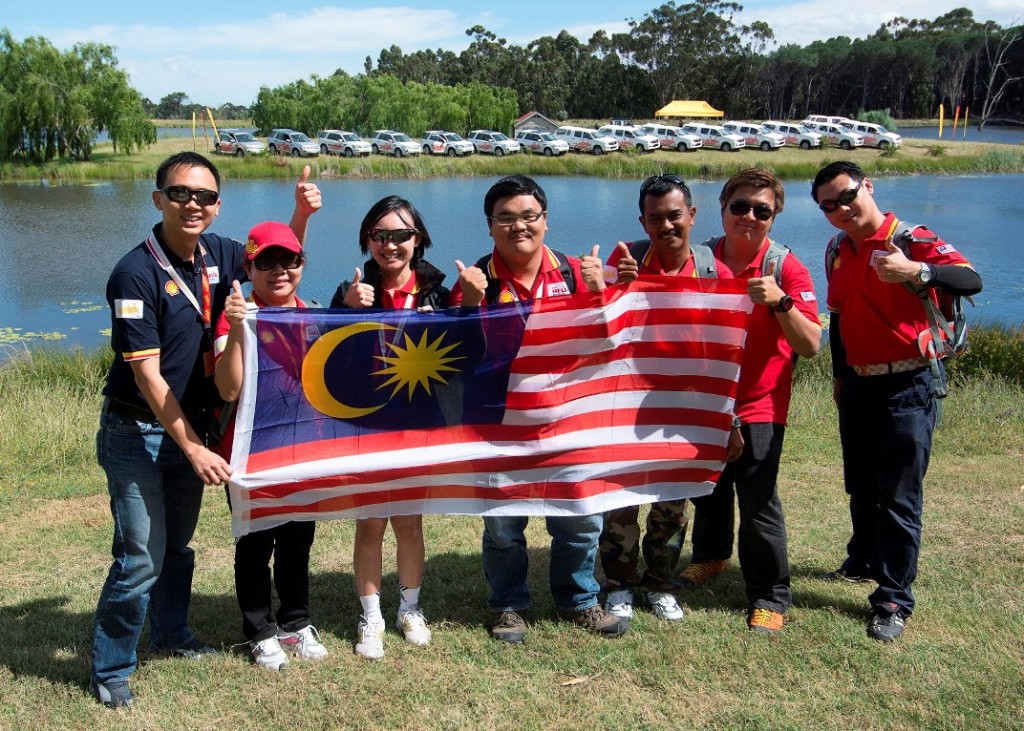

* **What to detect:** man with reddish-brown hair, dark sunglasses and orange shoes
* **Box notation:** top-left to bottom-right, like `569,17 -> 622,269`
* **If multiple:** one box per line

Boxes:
679,168 -> 821,634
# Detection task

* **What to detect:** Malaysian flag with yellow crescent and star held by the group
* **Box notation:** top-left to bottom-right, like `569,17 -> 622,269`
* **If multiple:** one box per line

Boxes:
229,277 -> 751,536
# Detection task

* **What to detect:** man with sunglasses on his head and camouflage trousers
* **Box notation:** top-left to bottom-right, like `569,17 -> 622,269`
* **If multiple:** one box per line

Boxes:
582,173 -> 738,621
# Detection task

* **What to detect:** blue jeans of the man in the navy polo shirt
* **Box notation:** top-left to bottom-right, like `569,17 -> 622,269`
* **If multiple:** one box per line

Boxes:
92,410 -> 203,683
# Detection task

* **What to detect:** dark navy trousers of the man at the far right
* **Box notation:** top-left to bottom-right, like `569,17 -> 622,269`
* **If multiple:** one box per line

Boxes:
839,368 -> 937,616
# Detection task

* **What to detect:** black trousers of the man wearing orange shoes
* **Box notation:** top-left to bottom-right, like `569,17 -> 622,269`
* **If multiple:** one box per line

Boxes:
692,424 -> 793,612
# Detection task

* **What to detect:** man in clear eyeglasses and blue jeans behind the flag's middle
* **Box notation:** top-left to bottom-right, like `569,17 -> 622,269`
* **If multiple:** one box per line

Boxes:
452,175 -> 629,644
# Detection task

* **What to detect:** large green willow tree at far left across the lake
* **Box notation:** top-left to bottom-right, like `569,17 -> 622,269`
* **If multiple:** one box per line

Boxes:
0,29 -> 157,162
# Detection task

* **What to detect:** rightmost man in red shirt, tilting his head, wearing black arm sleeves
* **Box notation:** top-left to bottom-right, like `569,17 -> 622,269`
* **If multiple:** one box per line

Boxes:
811,157 -> 982,642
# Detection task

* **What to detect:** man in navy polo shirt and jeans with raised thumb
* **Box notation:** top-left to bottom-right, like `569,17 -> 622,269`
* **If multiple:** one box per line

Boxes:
90,153 -> 321,707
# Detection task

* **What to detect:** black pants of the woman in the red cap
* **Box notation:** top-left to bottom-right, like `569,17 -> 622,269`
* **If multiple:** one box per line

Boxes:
234,520 -> 316,642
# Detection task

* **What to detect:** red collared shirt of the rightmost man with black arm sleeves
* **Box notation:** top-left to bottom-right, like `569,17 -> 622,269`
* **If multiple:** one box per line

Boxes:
827,213 -> 971,366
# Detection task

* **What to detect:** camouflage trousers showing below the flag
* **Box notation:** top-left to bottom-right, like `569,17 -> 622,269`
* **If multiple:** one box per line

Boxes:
599,499 -> 687,592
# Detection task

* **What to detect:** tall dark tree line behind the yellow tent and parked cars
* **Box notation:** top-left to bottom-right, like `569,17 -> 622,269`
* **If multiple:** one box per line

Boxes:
365,0 -> 1024,125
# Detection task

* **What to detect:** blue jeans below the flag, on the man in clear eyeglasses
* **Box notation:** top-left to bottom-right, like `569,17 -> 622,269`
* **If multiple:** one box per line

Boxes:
483,513 -> 604,611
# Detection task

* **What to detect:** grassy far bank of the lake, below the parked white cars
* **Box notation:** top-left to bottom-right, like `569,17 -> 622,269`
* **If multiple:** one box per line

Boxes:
0,137 -> 1024,183
